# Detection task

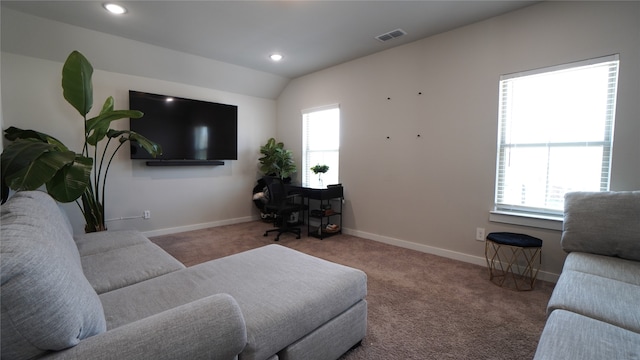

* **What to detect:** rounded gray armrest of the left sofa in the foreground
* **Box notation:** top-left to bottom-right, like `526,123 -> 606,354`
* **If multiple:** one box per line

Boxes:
44,294 -> 247,360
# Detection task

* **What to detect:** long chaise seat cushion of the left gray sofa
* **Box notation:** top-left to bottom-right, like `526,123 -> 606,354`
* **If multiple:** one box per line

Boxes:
100,245 -> 366,360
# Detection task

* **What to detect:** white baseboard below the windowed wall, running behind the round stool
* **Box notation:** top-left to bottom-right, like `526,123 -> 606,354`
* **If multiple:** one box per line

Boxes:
342,228 -> 560,283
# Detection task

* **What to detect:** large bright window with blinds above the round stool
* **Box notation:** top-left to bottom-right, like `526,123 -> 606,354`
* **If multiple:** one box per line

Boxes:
495,55 -> 619,216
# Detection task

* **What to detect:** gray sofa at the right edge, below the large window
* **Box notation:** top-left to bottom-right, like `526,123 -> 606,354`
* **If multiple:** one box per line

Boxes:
535,191 -> 640,360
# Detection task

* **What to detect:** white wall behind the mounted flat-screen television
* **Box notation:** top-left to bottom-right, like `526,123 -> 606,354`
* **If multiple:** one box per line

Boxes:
1,33 -> 276,235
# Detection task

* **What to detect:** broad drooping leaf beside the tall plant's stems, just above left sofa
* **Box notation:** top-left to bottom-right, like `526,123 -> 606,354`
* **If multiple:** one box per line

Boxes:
46,154 -> 93,202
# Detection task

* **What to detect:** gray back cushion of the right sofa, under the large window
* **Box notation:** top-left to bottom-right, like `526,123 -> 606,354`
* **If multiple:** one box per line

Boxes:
561,191 -> 640,261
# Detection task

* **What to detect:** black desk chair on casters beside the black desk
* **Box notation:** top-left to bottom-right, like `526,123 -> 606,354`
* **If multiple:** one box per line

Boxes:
263,176 -> 304,241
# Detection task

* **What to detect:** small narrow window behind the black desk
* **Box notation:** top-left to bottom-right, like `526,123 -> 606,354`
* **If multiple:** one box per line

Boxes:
302,105 -> 340,187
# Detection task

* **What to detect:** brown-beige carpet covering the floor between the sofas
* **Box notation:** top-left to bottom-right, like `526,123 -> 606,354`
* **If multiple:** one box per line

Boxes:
151,221 -> 553,360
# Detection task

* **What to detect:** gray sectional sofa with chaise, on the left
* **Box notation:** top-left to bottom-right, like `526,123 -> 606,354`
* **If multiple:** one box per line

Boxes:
0,191 -> 367,360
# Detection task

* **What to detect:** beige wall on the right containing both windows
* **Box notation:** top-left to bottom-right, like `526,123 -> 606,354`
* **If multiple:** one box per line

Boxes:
278,2 -> 640,279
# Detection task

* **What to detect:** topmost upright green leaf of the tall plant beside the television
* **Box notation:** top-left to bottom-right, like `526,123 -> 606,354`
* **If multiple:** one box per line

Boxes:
62,51 -> 93,117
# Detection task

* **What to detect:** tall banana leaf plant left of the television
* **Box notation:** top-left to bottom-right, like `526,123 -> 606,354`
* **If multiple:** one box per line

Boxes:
0,51 -> 162,232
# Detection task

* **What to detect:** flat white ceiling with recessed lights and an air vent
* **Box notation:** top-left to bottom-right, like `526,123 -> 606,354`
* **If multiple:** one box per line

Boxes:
1,0 -> 536,78
